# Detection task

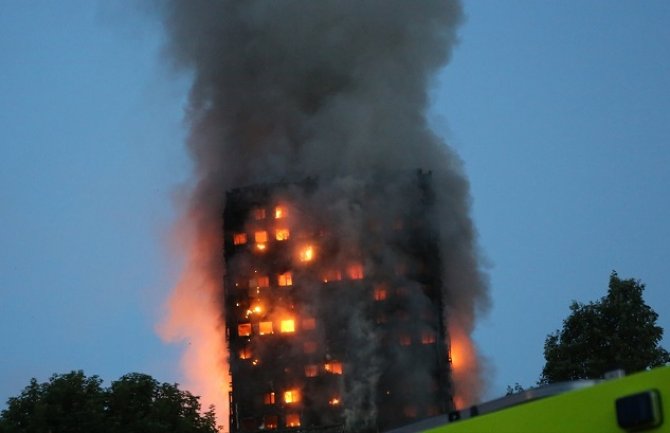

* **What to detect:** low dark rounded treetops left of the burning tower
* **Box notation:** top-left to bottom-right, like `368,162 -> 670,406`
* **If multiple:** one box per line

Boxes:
0,371 -> 217,433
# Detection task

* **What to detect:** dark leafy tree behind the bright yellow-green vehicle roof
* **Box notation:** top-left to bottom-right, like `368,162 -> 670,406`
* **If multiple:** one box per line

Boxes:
540,272 -> 670,383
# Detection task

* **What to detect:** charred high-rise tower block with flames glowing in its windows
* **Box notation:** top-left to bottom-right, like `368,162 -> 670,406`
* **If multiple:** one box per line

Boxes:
223,171 -> 453,433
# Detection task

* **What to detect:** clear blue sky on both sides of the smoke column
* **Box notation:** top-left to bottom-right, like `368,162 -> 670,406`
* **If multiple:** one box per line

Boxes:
0,0 -> 670,408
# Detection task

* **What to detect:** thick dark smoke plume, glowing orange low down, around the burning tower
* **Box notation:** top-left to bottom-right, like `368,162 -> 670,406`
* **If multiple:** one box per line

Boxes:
157,0 -> 488,426
